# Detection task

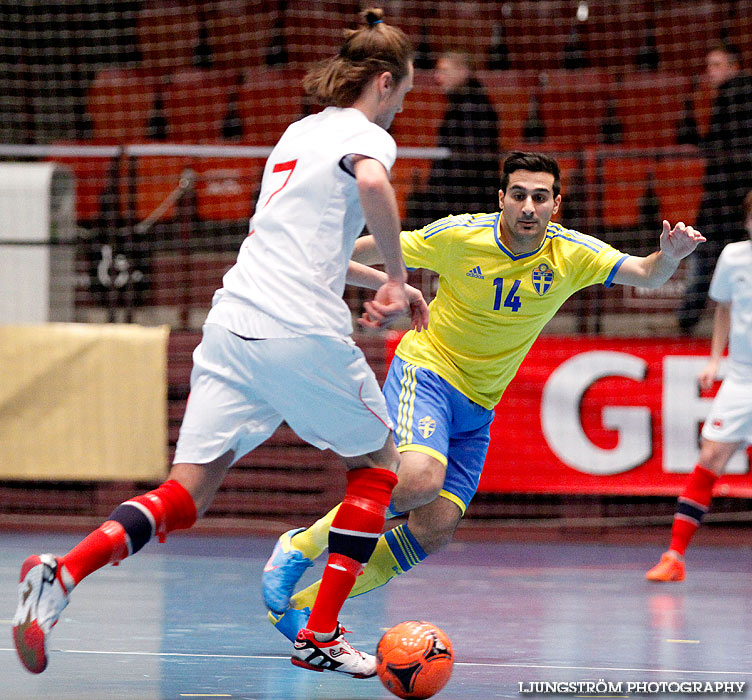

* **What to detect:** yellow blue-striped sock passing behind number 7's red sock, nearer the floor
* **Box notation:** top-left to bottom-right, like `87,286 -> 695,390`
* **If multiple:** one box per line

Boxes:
290,524 -> 426,609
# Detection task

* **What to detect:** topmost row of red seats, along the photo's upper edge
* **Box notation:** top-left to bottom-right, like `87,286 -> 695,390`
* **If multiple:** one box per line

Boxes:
129,0 -> 740,75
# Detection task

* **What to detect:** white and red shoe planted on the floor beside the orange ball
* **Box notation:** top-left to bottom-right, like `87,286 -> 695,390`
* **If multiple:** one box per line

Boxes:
290,623 -> 376,678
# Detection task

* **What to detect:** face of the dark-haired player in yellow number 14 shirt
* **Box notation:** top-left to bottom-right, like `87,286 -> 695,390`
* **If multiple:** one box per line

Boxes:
499,170 -> 561,253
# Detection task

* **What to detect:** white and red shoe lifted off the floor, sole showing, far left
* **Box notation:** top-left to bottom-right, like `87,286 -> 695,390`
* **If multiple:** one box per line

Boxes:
13,554 -> 73,673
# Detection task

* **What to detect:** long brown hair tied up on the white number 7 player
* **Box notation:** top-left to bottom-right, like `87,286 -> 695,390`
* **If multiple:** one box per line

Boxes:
303,7 -> 413,107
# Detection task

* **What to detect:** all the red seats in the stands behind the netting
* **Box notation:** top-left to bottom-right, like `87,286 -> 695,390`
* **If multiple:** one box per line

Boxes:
65,0 -> 736,227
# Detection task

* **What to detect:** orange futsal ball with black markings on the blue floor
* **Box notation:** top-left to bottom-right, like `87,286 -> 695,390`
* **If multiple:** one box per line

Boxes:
376,620 -> 454,698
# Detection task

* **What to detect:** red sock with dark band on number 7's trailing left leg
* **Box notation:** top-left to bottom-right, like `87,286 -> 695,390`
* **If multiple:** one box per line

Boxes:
58,480 -> 196,584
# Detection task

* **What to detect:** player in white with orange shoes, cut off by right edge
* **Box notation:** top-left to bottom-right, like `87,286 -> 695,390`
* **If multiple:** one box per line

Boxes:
646,192 -> 752,582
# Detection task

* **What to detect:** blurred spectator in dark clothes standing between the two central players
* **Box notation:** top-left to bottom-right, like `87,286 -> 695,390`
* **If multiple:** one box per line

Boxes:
405,52 -> 500,229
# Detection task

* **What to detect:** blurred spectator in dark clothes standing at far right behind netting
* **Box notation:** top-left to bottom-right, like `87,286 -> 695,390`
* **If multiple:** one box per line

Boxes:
678,44 -> 752,333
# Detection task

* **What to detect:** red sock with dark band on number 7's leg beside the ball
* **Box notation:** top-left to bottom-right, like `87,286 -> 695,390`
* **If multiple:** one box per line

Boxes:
308,468 -> 397,632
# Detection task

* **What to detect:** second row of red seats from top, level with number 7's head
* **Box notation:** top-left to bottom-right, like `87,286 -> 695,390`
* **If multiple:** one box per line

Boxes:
82,66 -> 724,149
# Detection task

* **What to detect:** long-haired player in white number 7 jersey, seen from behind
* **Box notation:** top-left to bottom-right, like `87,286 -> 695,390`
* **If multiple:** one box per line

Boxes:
13,9 -> 427,678
